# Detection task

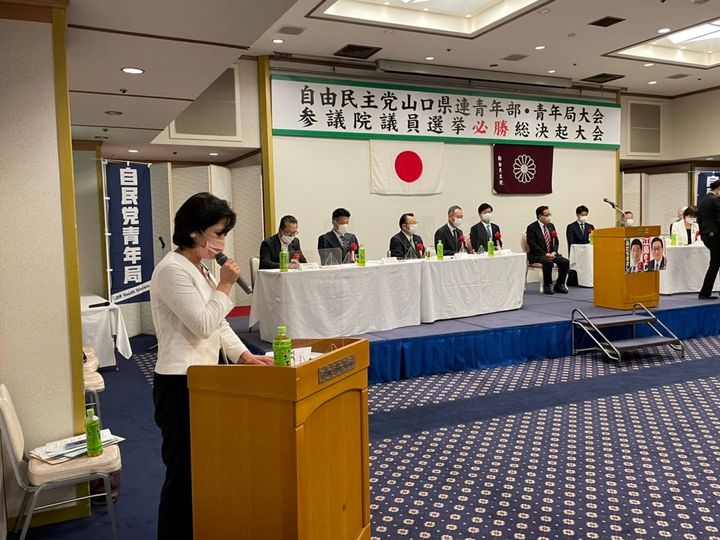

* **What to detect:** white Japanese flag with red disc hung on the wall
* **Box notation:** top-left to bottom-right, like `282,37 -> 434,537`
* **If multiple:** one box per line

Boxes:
370,139 -> 445,195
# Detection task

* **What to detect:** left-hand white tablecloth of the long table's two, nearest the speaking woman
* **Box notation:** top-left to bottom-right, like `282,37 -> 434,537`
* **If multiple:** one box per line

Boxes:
250,260 -> 422,341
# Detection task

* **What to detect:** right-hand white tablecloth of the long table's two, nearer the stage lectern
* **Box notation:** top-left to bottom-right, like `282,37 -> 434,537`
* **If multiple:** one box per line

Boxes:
421,253 -> 527,322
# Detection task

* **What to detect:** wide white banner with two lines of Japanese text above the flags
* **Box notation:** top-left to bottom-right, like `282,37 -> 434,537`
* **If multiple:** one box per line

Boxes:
272,75 -> 620,149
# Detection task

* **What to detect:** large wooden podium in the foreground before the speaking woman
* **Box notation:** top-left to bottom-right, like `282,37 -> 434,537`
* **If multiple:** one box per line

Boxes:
188,338 -> 370,540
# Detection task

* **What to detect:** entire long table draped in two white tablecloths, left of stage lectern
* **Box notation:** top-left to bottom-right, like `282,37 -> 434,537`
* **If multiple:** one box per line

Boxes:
250,254 -> 527,341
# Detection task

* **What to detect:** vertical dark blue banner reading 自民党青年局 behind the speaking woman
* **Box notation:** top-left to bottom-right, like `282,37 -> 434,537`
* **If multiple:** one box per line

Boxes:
105,163 -> 155,304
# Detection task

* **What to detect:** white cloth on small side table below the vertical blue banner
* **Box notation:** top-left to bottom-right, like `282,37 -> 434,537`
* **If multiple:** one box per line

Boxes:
80,294 -> 132,367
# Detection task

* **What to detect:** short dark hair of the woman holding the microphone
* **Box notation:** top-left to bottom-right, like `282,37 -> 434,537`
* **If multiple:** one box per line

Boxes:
173,193 -> 236,248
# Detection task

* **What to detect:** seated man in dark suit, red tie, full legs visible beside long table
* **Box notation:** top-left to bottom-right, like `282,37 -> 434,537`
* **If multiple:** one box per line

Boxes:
525,206 -> 570,294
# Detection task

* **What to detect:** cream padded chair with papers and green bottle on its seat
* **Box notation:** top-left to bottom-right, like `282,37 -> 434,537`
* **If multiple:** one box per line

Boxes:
0,384 -> 122,540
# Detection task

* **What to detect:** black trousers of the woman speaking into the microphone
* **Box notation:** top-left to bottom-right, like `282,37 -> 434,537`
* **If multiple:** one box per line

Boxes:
153,373 -> 193,540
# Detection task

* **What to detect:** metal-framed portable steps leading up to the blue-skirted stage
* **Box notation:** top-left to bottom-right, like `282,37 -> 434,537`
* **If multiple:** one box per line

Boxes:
571,303 -> 685,361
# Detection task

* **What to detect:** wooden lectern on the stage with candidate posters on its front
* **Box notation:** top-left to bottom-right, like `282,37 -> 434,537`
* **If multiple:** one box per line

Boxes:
592,225 -> 660,309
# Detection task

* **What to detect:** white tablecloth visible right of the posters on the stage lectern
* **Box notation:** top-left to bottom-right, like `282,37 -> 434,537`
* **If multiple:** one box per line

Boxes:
660,244 -> 720,294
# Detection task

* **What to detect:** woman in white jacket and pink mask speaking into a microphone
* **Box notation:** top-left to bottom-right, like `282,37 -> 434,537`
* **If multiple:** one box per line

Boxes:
150,193 -> 272,540
